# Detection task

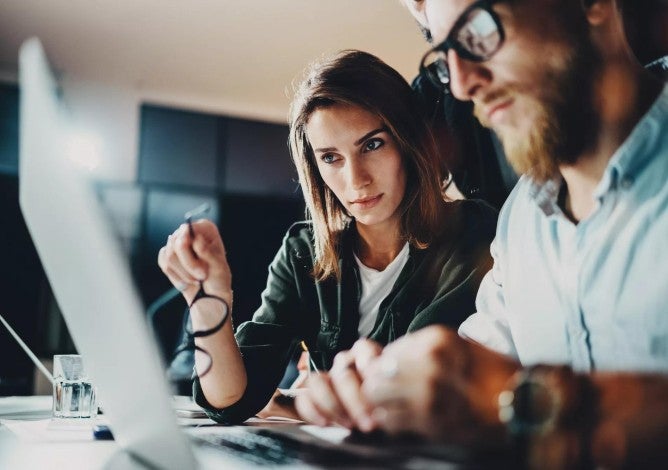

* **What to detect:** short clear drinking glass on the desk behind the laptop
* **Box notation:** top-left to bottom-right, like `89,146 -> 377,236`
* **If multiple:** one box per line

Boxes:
53,354 -> 97,418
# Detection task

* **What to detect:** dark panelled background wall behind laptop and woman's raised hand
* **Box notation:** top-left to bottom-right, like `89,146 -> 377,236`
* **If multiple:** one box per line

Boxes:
0,84 -> 304,395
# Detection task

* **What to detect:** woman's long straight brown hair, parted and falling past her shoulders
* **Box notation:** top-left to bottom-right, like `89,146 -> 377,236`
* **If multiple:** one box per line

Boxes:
290,50 -> 443,280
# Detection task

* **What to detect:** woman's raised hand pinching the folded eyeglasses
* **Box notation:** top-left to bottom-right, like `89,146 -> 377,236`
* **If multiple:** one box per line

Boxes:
158,220 -> 232,308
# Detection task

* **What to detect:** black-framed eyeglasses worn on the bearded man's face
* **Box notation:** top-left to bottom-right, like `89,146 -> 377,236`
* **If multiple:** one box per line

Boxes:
420,0 -> 505,91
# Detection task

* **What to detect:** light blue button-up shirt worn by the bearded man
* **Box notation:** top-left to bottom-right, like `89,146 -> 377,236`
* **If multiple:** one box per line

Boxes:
459,82 -> 668,372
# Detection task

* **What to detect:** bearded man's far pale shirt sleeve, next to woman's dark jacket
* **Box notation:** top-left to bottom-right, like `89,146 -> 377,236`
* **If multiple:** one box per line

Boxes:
459,236 -> 518,359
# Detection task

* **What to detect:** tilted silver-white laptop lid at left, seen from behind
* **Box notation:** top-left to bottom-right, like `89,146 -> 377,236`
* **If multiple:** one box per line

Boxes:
19,38 -> 196,469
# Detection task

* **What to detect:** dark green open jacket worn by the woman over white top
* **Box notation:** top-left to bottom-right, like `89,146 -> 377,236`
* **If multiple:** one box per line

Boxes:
193,200 -> 497,423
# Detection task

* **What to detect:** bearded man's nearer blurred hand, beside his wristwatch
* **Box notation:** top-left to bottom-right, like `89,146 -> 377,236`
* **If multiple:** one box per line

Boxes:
360,326 -> 520,446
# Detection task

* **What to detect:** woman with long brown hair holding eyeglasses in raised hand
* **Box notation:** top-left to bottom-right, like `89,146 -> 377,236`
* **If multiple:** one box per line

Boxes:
159,51 -> 496,423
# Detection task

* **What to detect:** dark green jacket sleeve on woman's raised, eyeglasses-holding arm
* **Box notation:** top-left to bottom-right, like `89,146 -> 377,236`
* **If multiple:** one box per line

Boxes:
193,227 -> 305,424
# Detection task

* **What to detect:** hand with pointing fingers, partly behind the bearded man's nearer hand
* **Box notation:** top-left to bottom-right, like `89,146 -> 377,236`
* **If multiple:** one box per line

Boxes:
295,339 -> 382,431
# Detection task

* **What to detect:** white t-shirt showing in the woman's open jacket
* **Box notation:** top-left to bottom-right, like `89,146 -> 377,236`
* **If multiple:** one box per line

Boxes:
355,242 -> 409,338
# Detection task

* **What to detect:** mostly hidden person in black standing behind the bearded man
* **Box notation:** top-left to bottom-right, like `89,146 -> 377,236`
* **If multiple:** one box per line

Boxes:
402,0 -> 668,209
